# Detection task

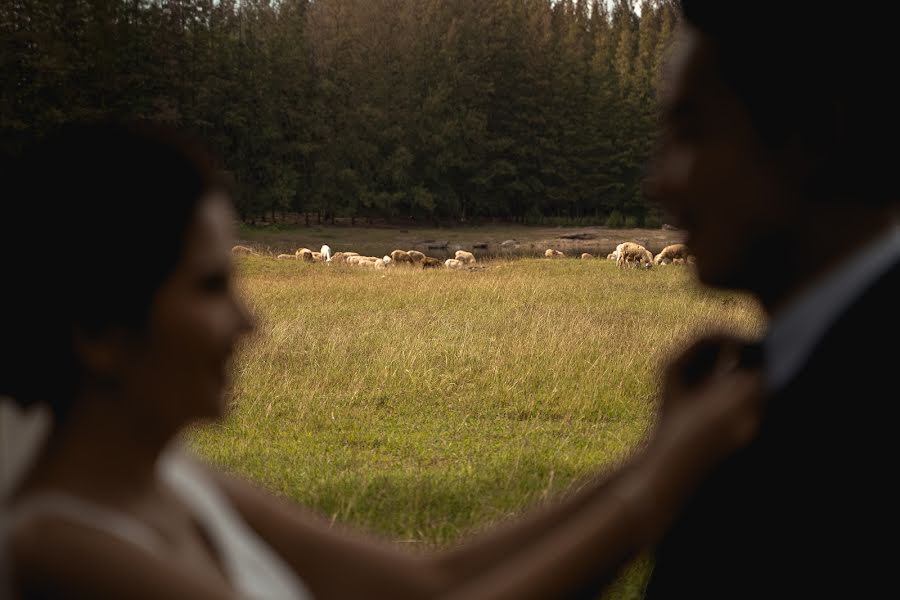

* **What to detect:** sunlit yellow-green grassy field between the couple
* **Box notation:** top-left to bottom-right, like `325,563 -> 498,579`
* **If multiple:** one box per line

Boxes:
191,256 -> 762,598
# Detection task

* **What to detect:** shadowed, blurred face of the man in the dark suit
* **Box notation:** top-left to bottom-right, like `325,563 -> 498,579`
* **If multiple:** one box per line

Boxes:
650,26 -> 792,292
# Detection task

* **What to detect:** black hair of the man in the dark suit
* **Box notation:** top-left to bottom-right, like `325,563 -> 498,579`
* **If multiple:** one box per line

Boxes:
681,0 -> 900,204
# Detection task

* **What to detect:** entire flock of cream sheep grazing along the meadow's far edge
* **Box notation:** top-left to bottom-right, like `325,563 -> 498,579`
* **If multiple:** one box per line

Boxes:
231,242 -> 694,270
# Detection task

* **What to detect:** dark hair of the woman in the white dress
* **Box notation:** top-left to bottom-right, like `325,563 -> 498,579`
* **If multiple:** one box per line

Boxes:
0,123 -> 230,420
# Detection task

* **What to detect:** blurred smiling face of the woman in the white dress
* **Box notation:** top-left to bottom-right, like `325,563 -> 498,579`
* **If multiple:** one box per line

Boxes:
119,194 -> 253,428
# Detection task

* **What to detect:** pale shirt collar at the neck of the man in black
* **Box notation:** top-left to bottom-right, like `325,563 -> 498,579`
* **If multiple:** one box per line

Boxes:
763,222 -> 900,392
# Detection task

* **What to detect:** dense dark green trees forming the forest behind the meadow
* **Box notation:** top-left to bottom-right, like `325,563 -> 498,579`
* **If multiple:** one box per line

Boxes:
0,0 -> 675,224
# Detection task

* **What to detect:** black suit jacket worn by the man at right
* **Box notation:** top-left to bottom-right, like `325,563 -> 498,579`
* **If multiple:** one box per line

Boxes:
647,264 -> 900,600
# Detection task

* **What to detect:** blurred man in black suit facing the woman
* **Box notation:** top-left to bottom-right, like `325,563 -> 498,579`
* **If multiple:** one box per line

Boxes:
604,0 -> 900,600
